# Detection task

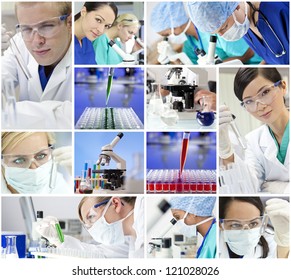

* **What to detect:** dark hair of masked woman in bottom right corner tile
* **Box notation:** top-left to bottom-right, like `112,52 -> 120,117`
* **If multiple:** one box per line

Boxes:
219,196 -> 270,258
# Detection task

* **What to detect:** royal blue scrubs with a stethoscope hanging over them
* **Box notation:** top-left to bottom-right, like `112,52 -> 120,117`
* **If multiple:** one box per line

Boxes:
244,2 -> 289,64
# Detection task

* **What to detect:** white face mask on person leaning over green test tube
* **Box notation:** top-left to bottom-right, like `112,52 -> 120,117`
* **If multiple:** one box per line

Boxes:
88,200 -> 133,245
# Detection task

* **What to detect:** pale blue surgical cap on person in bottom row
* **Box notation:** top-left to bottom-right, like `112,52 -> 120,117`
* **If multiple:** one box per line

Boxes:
170,196 -> 216,217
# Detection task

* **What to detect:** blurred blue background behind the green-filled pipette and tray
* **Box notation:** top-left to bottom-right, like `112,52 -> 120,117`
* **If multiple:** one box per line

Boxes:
75,68 -> 144,124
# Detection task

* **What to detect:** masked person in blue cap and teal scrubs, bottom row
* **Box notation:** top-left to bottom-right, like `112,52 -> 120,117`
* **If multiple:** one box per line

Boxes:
170,196 -> 216,258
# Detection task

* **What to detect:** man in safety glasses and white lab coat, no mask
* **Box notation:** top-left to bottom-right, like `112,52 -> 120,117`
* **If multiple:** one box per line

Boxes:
2,2 -> 72,128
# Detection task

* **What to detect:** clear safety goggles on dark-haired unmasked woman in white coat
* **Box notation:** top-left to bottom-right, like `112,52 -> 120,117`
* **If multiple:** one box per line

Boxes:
240,81 -> 282,113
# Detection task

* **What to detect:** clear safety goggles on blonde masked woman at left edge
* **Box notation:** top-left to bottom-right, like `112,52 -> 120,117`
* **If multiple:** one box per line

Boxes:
1,146 -> 53,169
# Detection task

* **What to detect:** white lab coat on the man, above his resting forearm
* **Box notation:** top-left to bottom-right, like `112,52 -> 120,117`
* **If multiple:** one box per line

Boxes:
1,33 -> 72,102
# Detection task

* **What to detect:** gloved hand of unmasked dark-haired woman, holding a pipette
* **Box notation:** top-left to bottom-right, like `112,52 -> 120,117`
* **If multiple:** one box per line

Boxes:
219,105 -> 233,159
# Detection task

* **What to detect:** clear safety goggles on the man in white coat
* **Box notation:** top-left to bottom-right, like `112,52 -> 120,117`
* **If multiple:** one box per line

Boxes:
16,15 -> 69,42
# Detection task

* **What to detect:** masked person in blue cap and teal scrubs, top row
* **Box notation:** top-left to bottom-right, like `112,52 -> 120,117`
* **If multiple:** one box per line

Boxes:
150,2 -> 262,64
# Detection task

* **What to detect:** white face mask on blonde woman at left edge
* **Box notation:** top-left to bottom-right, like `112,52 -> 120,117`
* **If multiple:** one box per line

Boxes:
4,160 -> 53,194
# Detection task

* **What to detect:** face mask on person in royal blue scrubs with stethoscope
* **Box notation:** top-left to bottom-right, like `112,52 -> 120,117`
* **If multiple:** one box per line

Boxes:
221,3 -> 250,41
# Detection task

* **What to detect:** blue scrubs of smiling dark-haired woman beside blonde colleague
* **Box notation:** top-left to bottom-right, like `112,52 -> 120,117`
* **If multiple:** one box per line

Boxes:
74,36 -> 96,64
